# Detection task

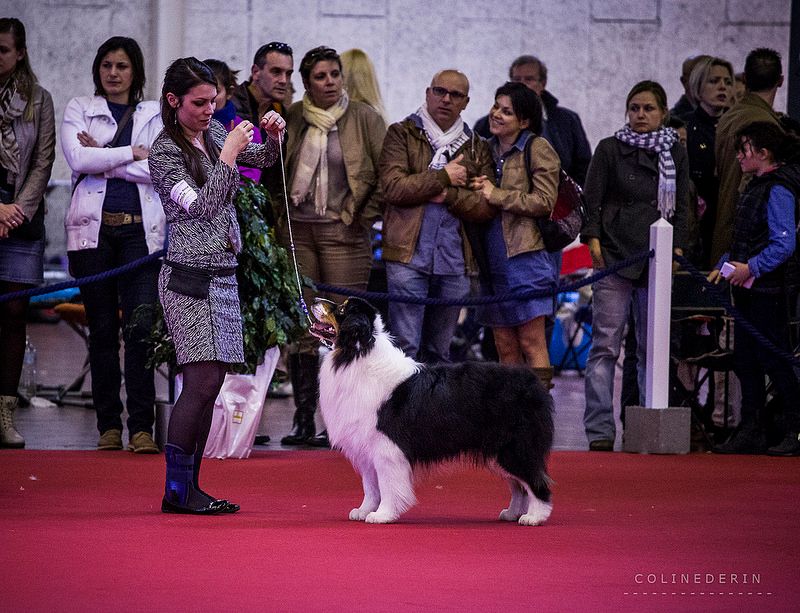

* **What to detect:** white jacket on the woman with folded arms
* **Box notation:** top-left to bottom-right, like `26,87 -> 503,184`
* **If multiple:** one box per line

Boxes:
59,96 -> 165,253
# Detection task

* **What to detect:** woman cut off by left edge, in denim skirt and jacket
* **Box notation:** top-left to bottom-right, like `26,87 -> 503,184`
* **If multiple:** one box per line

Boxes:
0,17 -> 56,447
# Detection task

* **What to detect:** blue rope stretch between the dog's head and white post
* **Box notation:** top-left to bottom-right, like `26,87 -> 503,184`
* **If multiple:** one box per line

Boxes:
314,249 -> 655,306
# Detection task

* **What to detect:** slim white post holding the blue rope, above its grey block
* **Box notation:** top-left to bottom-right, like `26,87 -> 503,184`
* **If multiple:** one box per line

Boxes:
645,219 -> 672,409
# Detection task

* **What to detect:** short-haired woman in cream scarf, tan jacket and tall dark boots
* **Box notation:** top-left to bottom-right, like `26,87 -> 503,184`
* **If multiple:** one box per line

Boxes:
281,47 -> 386,446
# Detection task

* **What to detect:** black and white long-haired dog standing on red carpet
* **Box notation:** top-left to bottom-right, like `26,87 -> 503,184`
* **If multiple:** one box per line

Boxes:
311,298 -> 553,526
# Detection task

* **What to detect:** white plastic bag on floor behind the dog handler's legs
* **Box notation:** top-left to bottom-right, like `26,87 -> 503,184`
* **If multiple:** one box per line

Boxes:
203,347 -> 280,459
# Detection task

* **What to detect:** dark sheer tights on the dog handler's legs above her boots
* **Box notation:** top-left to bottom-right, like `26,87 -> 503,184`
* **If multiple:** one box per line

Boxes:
167,362 -> 228,455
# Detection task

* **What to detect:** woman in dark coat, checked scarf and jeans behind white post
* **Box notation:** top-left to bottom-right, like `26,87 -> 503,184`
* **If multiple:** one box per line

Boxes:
581,81 -> 689,451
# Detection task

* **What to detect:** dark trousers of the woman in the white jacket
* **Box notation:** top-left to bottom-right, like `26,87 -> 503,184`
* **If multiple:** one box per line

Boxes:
68,224 -> 161,436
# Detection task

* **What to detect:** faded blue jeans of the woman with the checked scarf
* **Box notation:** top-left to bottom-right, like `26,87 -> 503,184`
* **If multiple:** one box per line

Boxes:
583,274 -> 647,442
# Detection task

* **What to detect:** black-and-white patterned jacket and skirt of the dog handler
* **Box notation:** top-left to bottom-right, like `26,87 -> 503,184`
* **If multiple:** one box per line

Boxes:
148,120 -> 278,365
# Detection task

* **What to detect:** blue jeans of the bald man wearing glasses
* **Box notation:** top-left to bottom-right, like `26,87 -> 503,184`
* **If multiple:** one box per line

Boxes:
386,262 -> 470,362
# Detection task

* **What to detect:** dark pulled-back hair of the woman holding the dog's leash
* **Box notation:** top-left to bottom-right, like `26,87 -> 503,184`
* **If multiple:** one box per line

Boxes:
161,57 -> 219,187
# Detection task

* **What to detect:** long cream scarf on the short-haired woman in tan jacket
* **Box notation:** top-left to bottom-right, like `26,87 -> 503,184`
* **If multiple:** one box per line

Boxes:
290,90 -> 350,216
